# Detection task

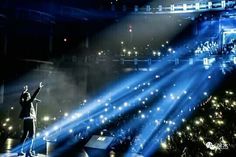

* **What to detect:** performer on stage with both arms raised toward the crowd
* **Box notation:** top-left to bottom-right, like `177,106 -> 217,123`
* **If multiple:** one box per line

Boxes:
18,82 -> 43,157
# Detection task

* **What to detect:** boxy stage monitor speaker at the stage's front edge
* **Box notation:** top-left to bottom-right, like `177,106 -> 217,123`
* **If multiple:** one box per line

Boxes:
85,135 -> 114,157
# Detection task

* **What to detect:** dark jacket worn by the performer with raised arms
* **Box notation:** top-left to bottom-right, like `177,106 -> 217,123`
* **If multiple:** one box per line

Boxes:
19,88 -> 40,119
